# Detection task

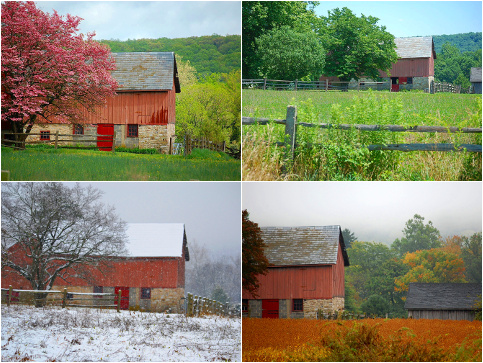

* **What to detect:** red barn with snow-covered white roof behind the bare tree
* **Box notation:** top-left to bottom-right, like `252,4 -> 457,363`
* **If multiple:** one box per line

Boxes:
2,223 -> 189,311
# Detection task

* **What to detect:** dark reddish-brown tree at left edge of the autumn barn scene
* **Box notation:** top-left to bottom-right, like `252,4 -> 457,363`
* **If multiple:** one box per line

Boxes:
242,209 -> 269,297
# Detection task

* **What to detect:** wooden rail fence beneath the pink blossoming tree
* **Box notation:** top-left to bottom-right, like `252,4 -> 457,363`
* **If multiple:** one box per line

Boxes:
2,131 -> 116,151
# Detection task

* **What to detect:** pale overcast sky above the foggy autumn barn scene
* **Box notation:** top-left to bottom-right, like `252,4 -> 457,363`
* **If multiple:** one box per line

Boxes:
242,182 -> 482,245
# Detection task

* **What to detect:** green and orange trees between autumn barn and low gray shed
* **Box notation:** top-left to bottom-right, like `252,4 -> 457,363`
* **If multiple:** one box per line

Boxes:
342,214 -> 482,317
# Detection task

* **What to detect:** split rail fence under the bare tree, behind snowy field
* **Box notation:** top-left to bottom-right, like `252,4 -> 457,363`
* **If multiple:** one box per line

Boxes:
2,286 -> 121,312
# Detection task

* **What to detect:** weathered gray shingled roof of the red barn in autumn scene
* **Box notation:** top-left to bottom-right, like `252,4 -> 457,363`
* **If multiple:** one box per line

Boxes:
260,226 -> 349,266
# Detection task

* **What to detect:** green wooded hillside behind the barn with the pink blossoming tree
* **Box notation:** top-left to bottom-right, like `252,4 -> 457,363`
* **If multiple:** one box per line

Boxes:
101,34 -> 241,76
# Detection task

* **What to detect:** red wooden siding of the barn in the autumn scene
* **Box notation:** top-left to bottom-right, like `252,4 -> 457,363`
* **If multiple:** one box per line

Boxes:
243,262 -> 336,299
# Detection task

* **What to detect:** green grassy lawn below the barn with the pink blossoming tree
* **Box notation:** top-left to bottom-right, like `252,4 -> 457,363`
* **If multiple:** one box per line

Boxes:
2,147 -> 241,181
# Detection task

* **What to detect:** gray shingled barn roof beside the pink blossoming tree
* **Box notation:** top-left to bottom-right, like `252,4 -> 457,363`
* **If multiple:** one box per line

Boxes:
112,52 -> 180,92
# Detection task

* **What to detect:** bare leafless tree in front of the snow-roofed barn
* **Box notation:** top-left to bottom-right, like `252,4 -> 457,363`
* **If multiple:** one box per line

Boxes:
2,183 -> 127,304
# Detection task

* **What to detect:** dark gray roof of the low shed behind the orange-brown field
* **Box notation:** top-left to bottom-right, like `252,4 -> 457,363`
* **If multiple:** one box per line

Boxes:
404,283 -> 481,310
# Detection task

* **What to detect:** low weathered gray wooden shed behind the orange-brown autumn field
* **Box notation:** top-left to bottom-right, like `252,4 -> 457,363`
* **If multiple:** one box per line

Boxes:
404,283 -> 481,321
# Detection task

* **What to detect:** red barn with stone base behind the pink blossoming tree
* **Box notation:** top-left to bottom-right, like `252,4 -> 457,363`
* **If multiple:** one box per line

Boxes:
25,52 -> 181,153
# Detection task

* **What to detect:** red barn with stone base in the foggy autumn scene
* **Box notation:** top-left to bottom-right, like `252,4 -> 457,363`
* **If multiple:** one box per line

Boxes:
243,226 -> 349,319
